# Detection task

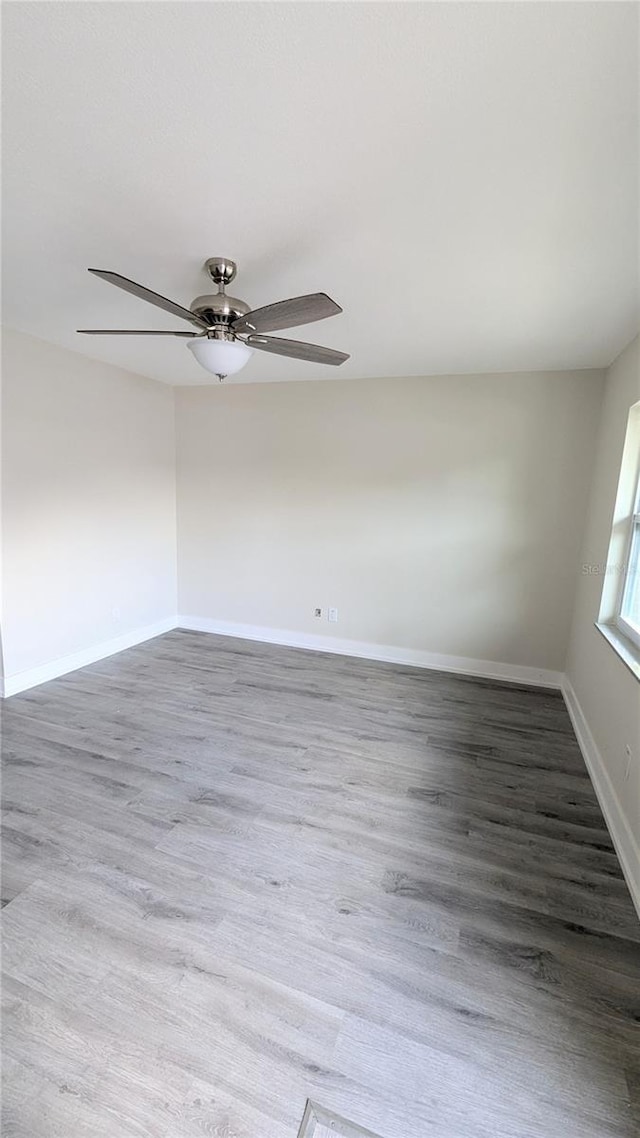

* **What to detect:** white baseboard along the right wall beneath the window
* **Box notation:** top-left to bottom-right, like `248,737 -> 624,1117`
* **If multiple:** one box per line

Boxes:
563,676 -> 640,917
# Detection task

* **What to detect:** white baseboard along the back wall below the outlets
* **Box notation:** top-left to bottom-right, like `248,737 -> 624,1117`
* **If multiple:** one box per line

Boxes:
178,617 -> 563,687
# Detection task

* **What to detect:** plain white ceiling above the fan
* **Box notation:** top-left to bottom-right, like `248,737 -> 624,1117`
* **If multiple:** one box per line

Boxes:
3,0 -> 639,384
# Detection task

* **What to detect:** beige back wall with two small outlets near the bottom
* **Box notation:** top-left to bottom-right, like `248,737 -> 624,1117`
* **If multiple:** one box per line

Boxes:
175,371 -> 602,669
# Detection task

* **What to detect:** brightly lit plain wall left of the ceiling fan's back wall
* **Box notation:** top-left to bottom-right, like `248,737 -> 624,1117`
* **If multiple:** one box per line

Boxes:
2,331 -> 175,677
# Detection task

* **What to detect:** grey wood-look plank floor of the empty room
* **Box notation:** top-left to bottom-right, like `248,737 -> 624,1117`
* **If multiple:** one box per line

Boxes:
2,632 -> 640,1138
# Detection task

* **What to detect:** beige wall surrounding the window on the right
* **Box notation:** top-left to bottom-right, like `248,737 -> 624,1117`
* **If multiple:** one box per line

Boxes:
567,338 -> 640,855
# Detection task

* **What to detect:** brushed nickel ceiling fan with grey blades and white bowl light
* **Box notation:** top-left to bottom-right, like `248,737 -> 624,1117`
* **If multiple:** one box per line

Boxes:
77,257 -> 348,380
